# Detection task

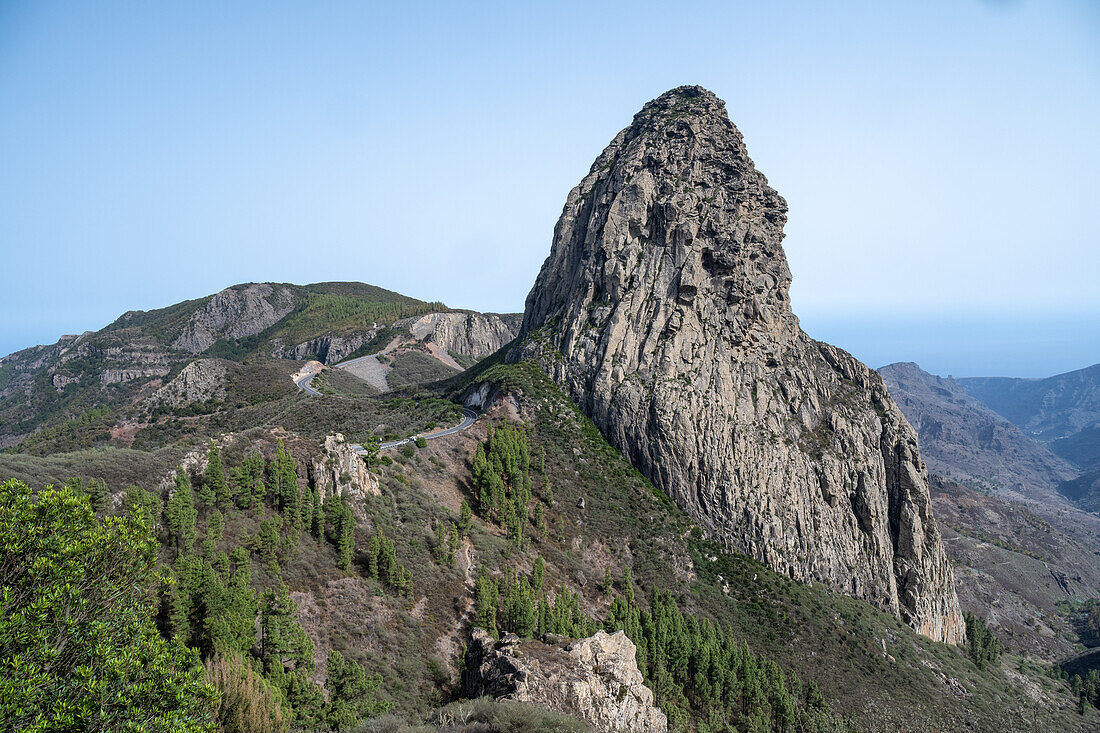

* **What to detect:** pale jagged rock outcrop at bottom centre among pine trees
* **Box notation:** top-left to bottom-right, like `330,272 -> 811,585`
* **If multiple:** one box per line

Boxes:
463,628 -> 668,733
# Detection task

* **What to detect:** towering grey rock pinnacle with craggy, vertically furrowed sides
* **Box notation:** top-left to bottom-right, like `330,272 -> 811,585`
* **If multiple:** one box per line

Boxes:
512,87 -> 965,643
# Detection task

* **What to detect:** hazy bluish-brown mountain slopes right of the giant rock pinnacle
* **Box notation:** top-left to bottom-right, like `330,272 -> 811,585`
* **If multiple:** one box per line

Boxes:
878,363 -> 1100,657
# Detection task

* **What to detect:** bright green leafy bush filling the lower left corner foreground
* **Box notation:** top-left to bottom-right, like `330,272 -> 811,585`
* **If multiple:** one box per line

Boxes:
0,481 -> 215,733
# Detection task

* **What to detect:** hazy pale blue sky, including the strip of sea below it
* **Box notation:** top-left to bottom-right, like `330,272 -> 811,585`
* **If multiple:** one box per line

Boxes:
0,0 -> 1100,375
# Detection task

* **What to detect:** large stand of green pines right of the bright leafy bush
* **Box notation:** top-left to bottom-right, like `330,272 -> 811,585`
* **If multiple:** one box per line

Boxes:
158,435 -> 396,730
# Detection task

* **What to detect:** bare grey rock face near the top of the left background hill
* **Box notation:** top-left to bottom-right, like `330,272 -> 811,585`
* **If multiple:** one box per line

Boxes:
172,283 -> 296,353
